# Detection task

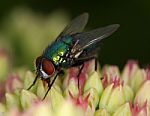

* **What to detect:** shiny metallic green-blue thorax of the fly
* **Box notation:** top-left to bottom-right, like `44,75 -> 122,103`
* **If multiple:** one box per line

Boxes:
43,36 -> 72,65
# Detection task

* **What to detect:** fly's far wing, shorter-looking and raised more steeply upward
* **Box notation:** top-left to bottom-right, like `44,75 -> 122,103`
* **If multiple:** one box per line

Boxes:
58,13 -> 89,38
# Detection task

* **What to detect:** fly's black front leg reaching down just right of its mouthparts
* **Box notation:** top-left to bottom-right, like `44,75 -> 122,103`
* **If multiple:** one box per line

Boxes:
43,70 -> 64,100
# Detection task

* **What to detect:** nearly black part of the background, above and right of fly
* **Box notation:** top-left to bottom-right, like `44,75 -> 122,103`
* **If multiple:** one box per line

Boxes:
0,0 -> 150,67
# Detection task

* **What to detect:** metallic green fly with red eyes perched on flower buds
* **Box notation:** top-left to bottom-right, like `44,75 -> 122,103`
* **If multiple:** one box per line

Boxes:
28,13 -> 119,99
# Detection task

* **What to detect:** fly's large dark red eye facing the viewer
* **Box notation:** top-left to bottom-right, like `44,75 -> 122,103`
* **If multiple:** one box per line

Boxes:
42,59 -> 55,75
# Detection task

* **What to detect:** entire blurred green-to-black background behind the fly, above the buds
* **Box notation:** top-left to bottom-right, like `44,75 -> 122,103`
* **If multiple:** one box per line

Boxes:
0,0 -> 150,68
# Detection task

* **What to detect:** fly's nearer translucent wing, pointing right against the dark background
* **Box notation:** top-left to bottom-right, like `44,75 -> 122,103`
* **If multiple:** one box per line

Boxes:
74,24 -> 120,51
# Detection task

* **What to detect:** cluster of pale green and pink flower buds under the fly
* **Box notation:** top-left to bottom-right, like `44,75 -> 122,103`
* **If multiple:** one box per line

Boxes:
0,50 -> 150,116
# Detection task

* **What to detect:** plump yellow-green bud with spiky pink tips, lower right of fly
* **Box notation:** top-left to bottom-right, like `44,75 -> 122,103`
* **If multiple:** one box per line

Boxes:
99,79 -> 130,113
